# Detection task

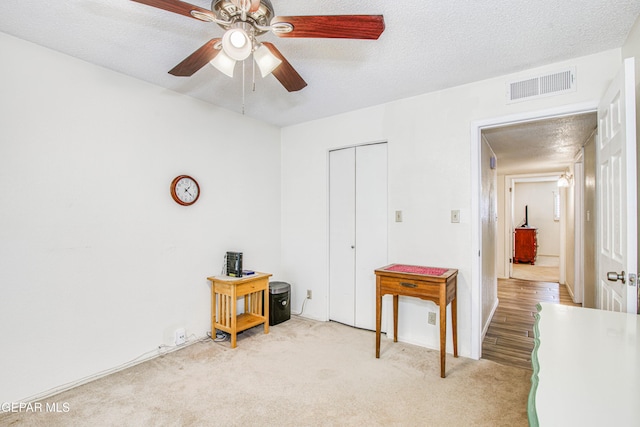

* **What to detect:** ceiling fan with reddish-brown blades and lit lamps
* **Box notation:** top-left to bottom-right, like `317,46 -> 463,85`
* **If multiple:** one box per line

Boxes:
133,0 -> 384,92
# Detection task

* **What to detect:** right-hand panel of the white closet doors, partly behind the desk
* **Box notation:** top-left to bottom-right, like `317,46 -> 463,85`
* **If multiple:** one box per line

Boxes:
355,144 -> 387,330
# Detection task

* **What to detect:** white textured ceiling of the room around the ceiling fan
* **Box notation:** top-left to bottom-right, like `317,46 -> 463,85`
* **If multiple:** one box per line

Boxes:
0,0 -> 640,126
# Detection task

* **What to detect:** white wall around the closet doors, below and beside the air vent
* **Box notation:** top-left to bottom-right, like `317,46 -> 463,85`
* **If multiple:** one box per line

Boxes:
282,49 -> 620,356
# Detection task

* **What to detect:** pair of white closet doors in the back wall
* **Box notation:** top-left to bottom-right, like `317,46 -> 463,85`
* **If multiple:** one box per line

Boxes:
329,144 -> 387,330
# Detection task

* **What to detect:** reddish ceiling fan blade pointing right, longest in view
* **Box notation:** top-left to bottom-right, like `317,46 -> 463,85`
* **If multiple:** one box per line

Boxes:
271,15 -> 384,40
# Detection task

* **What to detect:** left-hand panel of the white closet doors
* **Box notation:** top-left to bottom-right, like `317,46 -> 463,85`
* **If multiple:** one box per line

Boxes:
329,148 -> 356,326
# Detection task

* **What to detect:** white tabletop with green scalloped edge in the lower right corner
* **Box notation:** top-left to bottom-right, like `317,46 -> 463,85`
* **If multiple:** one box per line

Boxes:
528,303 -> 640,427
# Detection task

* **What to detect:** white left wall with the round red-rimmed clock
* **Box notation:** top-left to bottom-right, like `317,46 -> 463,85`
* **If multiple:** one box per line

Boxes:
0,33 -> 280,402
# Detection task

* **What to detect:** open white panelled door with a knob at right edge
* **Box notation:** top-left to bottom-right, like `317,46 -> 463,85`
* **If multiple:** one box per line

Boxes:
596,58 -> 638,313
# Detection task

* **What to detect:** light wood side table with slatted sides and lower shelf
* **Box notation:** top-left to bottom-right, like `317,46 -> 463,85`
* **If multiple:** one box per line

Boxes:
207,272 -> 271,348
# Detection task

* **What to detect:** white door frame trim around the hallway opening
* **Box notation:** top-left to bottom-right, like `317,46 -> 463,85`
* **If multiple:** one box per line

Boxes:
471,100 -> 599,359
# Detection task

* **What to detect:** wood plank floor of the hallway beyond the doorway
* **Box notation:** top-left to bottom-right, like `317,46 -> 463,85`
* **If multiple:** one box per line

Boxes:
482,279 -> 580,369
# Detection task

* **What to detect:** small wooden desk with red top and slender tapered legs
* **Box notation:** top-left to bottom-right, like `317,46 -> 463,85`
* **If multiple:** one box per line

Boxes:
375,264 -> 458,378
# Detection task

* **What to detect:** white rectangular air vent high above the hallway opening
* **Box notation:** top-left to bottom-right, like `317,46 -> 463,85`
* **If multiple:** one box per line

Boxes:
507,67 -> 576,104
